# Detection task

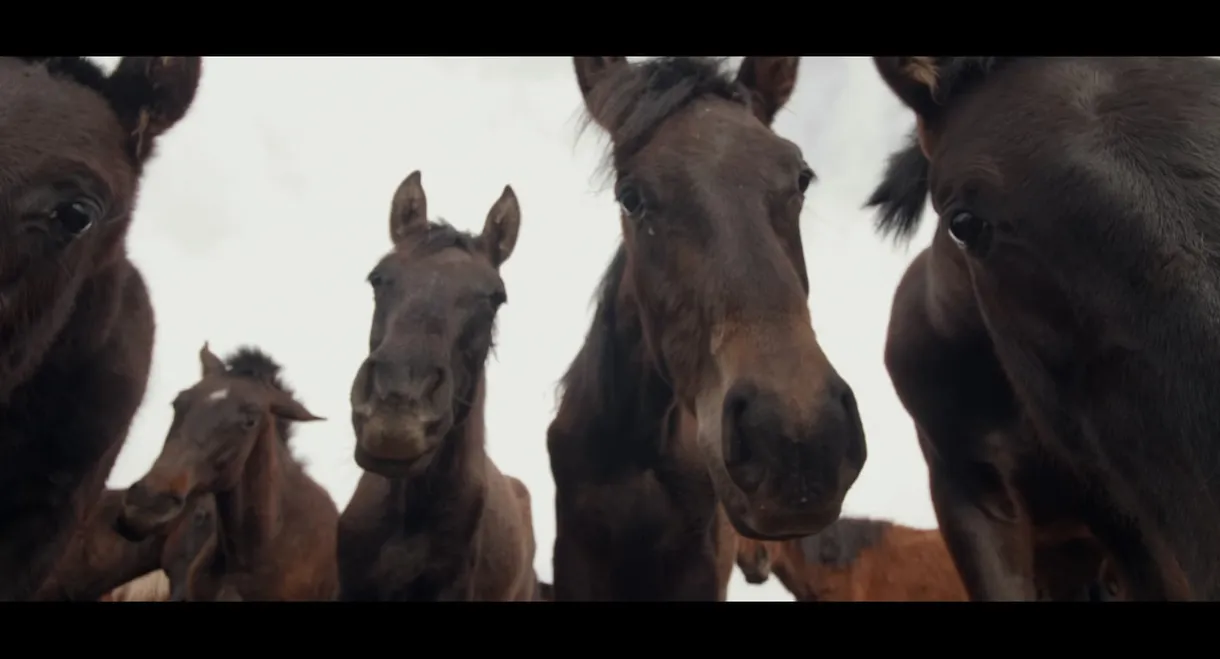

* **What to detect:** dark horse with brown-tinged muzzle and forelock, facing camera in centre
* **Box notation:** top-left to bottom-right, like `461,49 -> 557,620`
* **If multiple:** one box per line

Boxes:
548,57 -> 865,600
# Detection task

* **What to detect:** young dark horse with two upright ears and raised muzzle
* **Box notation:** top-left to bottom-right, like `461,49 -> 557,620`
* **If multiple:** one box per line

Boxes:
339,172 -> 538,600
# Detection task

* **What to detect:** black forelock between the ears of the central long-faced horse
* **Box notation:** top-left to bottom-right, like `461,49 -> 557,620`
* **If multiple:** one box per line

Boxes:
581,57 -> 748,178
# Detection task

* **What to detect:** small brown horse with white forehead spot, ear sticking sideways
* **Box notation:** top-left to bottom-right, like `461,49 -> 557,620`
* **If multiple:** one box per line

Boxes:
113,343 -> 339,600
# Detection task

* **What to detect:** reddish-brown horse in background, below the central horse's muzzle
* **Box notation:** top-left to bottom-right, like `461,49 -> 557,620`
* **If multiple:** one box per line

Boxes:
737,517 -> 967,602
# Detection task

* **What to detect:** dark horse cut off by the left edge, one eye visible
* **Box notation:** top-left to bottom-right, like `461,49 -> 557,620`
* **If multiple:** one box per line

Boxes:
0,57 -> 200,600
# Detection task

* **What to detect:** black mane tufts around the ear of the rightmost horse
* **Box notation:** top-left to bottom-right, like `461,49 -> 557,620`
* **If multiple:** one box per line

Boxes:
864,57 -> 1015,243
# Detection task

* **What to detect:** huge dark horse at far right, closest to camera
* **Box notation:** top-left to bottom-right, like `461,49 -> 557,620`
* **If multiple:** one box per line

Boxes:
870,57 -> 1220,600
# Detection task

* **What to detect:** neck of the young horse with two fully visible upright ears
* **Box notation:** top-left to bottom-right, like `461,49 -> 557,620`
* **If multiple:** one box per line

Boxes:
390,370 -> 487,519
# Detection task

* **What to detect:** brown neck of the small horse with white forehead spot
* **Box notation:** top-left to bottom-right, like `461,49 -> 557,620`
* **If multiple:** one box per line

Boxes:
216,423 -> 295,565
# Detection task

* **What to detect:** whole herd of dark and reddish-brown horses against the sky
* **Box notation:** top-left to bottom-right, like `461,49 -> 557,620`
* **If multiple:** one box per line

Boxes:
0,56 -> 1220,602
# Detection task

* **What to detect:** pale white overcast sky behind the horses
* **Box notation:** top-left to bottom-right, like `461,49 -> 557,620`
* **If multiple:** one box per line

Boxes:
98,57 -> 936,600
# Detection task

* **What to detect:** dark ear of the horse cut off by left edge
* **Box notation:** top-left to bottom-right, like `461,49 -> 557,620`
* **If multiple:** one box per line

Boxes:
106,57 -> 203,162
